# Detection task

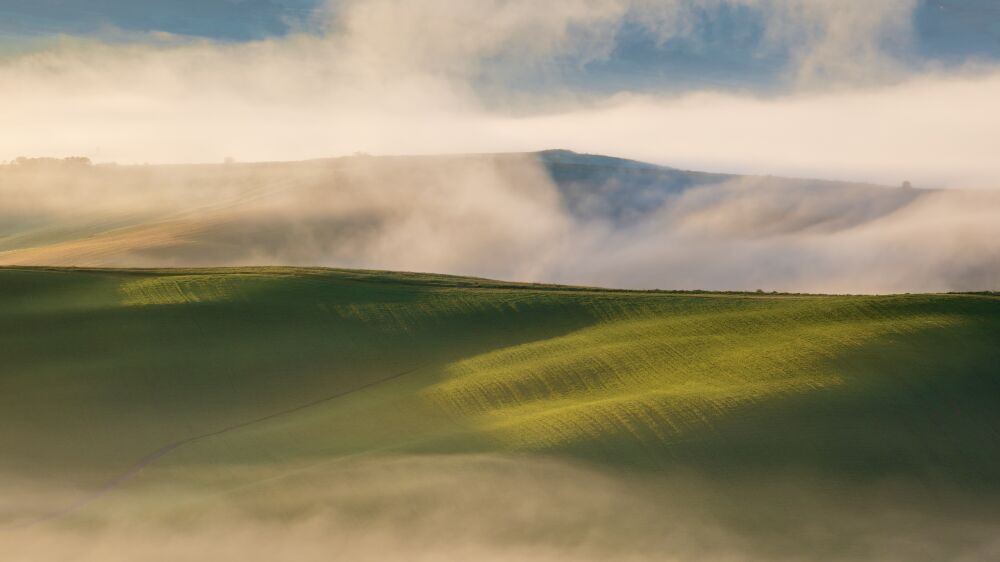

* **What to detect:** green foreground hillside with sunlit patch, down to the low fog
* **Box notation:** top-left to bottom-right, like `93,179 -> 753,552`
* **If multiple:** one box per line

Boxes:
0,269 -> 1000,487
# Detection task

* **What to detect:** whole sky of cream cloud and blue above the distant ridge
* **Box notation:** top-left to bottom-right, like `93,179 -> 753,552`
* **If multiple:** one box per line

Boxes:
0,0 -> 1000,188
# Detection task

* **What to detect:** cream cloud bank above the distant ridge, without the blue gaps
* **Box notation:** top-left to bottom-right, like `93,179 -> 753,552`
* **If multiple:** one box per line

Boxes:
0,0 -> 1000,187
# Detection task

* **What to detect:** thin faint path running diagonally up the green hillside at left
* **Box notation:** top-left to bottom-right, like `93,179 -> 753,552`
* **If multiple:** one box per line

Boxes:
15,364 -> 427,527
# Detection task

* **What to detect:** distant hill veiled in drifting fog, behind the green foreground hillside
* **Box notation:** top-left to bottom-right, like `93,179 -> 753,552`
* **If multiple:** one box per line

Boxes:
0,154 -> 1000,293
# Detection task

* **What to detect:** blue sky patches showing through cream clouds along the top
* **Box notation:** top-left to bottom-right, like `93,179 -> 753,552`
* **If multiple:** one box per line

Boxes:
0,0 -> 1000,78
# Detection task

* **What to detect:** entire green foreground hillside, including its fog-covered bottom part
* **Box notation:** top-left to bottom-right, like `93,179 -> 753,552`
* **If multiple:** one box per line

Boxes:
0,268 -> 1000,560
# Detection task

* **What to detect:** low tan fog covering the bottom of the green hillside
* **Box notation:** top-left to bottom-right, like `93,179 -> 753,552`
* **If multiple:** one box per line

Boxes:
0,455 -> 1000,562
